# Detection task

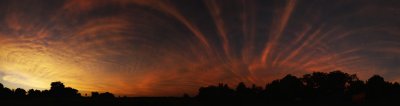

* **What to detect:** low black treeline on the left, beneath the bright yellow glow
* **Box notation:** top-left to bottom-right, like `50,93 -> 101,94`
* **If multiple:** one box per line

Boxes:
0,82 -> 115,99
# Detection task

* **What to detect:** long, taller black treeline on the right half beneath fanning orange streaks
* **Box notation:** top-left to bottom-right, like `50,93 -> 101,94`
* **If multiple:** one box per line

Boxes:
197,71 -> 400,105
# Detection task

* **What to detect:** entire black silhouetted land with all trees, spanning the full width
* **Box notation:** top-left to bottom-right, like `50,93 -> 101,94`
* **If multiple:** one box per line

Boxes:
0,71 -> 400,106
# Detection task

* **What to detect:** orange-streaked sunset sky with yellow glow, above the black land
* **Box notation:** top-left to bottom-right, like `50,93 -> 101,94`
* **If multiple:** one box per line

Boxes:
0,0 -> 400,96
